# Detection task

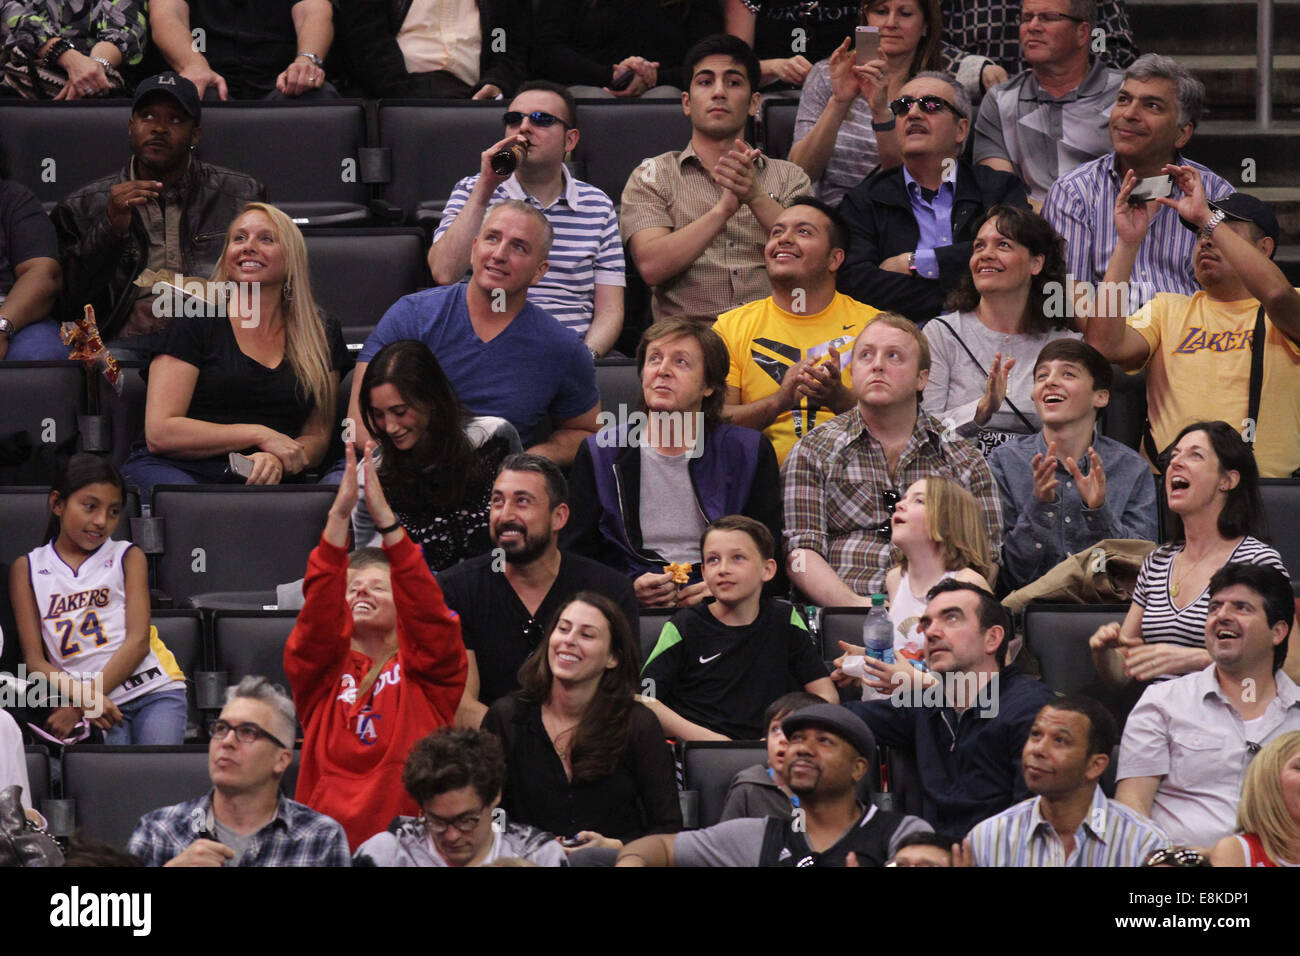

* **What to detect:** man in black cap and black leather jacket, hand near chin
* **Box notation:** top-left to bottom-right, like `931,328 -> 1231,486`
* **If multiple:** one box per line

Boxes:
52,73 -> 267,355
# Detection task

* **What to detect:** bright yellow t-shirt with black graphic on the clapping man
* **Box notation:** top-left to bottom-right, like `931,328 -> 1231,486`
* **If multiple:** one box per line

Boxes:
714,293 -> 880,463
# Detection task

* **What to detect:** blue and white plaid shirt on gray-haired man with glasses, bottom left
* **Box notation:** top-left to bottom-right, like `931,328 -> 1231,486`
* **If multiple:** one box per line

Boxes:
126,791 -> 352,866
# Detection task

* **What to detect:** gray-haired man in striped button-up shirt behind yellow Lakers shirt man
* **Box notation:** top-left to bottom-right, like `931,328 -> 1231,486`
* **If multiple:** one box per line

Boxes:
1043,53 -> 1232,306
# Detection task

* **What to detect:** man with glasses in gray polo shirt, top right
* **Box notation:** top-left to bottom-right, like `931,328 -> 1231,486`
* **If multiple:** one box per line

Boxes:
975,0 -> 1123,209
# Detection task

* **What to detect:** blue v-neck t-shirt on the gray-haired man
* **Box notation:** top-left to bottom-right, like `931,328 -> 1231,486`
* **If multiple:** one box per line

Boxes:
358,282 -> 601,447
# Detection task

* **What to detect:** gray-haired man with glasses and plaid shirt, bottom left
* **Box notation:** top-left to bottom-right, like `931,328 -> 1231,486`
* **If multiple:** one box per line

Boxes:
126,676 -> 351,866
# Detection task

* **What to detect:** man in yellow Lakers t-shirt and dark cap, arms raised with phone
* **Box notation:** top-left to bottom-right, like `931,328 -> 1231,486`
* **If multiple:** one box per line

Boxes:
1086,165 -> 1300,477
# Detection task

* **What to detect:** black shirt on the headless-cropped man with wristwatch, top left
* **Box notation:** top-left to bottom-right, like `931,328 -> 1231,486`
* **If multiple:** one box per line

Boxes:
186,0 -> 298,99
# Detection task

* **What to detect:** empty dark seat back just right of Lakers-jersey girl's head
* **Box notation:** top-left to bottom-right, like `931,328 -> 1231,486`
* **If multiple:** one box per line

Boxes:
146,485 -> 337,605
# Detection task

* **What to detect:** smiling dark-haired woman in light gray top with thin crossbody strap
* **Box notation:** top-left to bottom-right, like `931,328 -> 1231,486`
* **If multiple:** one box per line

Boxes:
922,206 -> 1083,453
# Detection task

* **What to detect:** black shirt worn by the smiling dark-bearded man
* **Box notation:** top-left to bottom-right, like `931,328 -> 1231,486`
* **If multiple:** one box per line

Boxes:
438,553 -> 639,706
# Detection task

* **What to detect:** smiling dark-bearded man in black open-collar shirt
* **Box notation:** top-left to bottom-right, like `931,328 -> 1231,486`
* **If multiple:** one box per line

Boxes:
438,454 -> 640,727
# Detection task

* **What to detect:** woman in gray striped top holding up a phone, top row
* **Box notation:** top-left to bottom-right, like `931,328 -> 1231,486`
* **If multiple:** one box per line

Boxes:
790,0 -> 944,206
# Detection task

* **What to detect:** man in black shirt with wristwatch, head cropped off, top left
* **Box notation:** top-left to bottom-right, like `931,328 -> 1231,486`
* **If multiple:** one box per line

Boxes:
150,0 -> 338,100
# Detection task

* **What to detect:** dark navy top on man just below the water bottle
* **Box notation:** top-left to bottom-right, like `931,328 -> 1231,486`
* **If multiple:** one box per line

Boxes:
845,666 -> 1056,840
